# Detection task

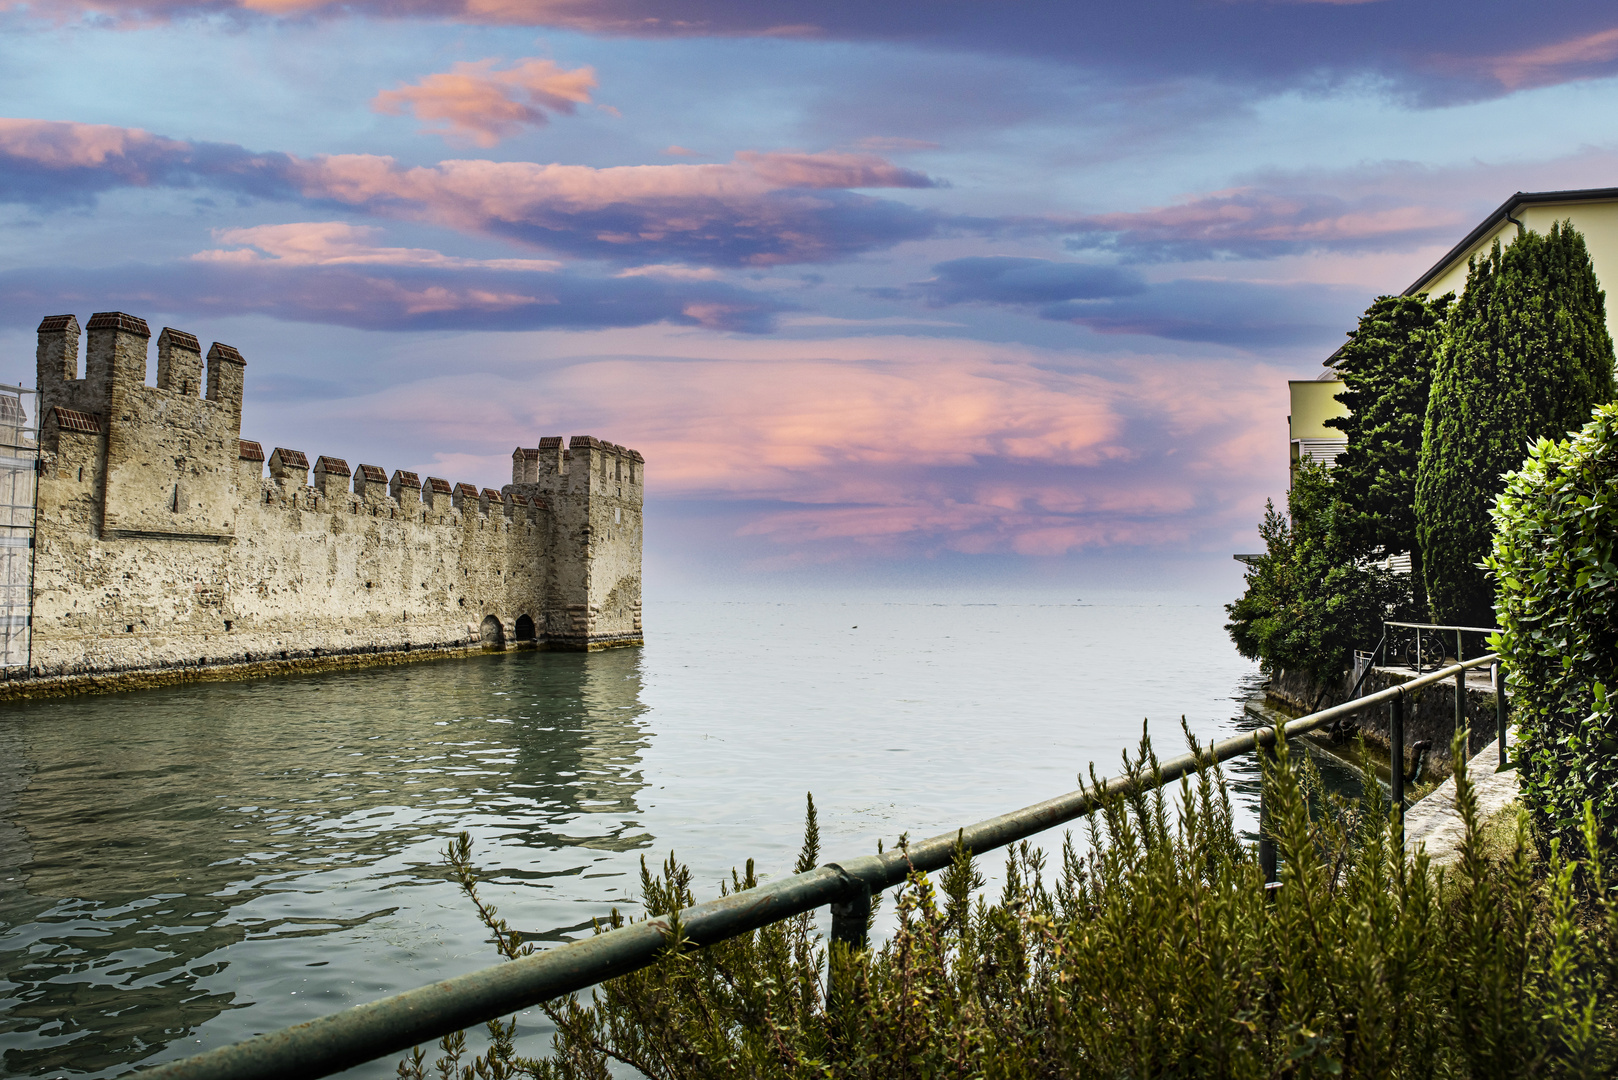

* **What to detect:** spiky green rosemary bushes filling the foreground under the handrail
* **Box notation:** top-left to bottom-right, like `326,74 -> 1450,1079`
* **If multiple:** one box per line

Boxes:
400,740 -> 1618,1080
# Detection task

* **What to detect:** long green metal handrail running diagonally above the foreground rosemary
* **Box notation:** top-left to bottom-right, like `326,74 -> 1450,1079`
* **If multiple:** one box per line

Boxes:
131,654 -> 1497,1080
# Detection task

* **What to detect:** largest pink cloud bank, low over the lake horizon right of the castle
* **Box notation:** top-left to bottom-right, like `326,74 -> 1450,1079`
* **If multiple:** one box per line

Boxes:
297,330 -> 1286,563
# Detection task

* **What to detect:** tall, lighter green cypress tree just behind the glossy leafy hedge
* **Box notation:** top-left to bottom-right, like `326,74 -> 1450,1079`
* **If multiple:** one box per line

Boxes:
1416,222 -> 1613,627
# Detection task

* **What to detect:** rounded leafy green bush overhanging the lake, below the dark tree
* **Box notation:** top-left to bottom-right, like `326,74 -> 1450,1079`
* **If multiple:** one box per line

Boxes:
1225,461 -> 1413,682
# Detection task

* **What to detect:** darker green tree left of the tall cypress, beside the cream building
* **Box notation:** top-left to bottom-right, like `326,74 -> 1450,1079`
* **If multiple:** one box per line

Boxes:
1327,293 -> 1455,583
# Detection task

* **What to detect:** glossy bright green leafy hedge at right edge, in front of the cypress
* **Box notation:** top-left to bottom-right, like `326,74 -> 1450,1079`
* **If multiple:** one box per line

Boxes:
1489,405 -> 1618,845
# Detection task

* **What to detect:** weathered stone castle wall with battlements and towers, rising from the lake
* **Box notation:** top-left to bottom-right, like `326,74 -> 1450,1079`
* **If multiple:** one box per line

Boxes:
14,313 -> 646,696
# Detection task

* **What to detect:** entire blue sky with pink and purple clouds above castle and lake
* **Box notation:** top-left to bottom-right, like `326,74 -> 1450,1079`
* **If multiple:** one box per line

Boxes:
0,0 -> 1618,597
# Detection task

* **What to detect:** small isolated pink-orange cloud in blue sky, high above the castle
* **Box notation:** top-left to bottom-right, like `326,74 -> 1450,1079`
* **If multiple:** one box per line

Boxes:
371,60 -> 595,146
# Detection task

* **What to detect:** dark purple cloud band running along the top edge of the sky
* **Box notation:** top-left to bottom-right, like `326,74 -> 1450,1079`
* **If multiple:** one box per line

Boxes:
26,0 -> 1618,102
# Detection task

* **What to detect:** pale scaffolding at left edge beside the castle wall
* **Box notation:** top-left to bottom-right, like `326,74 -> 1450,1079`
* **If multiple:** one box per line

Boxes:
0,385 -> 39,667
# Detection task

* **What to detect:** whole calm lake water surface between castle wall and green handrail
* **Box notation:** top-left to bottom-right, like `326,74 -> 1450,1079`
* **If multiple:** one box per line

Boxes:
0,594 -> 1257,1077
